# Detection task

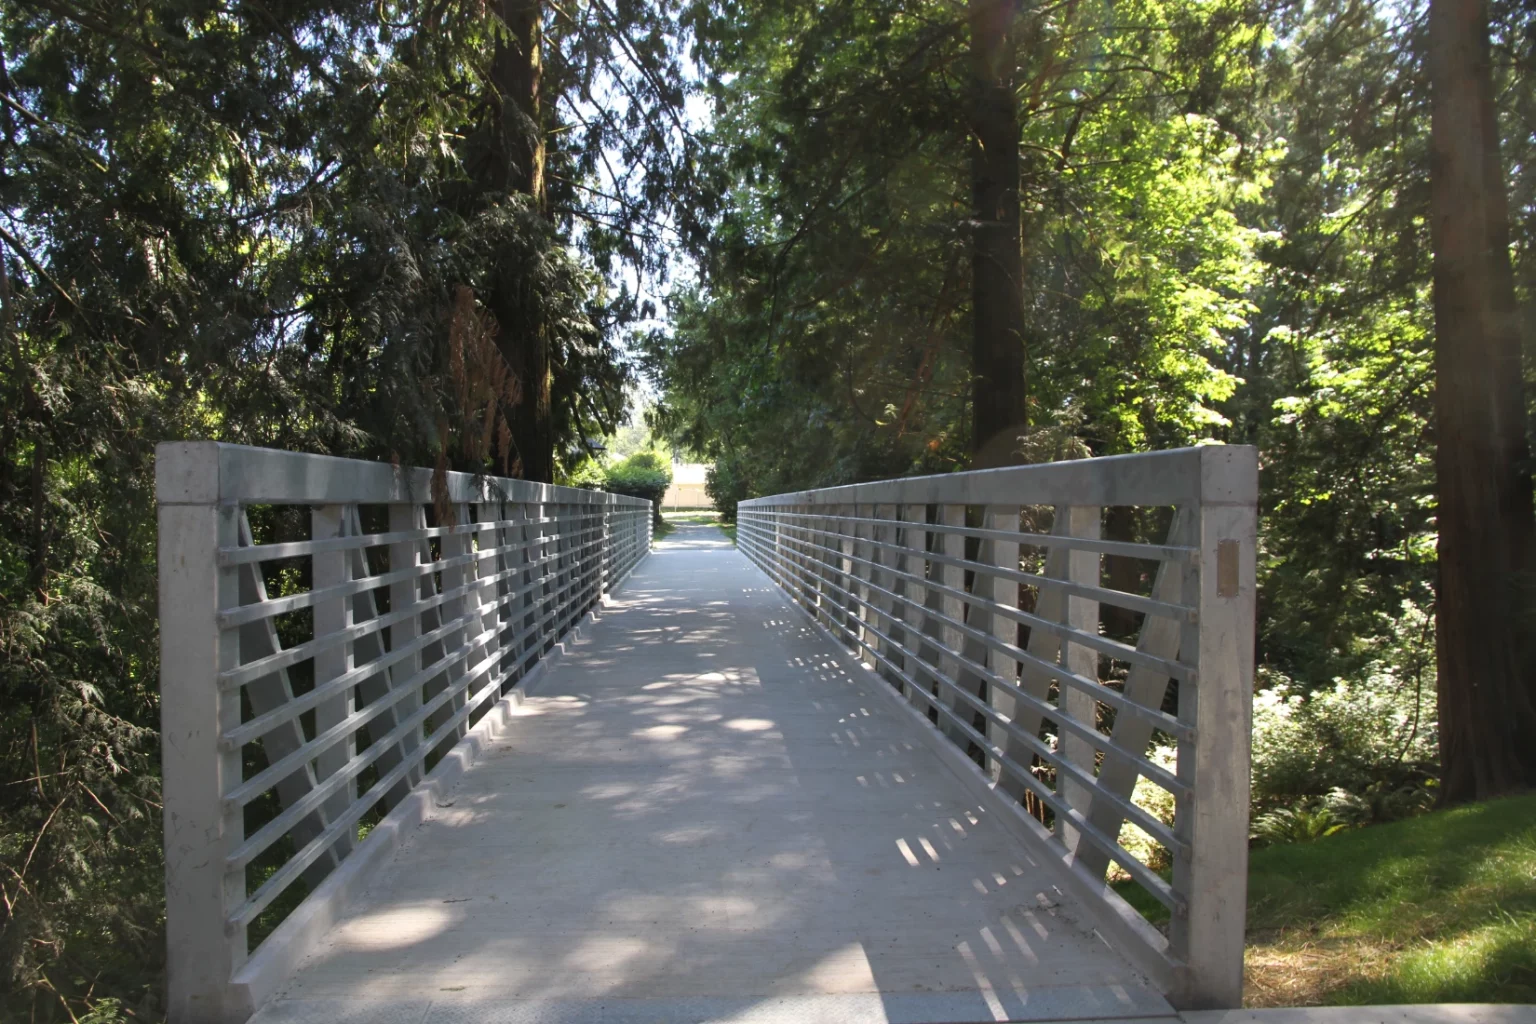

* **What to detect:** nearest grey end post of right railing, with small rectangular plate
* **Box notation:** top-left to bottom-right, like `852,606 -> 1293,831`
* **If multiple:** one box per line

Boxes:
1169,445 -> 1258,1009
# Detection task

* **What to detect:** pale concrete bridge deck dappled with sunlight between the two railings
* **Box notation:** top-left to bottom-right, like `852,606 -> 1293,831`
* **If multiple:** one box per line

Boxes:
255,527 -> 1172,1024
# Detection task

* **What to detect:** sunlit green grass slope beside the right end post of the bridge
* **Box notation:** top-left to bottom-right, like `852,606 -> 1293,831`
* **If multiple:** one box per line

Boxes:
1117,795 -> 1536,1006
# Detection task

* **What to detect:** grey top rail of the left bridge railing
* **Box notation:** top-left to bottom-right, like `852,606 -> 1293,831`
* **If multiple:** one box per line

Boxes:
155,441 -> 650,507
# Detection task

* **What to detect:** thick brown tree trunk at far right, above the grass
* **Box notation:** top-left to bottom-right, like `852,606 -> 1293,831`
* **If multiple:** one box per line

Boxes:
1428,0 -> 1536,804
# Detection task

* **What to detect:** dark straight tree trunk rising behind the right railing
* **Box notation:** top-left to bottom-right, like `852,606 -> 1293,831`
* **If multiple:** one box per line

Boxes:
969,0 -> 1028,453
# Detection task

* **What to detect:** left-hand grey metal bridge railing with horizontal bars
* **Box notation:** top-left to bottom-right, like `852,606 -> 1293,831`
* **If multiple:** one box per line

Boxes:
155,442 -> 651,1021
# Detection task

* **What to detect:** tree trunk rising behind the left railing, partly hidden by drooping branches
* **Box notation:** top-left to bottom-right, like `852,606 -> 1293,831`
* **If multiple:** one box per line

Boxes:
485,0 -> 554,482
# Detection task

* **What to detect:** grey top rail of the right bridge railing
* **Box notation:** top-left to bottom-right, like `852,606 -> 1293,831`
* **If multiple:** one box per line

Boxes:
740,445 -> 1258,510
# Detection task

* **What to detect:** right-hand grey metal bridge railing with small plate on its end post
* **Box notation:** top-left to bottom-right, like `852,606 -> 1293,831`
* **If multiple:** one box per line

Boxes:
737,445 -> 1258,1007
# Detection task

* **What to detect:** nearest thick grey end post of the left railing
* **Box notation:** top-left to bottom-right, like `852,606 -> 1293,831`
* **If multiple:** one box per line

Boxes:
155,444 -> 244,1024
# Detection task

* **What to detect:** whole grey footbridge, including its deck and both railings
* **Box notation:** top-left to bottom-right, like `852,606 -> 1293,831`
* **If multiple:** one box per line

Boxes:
157,442 -> 1256,1024
